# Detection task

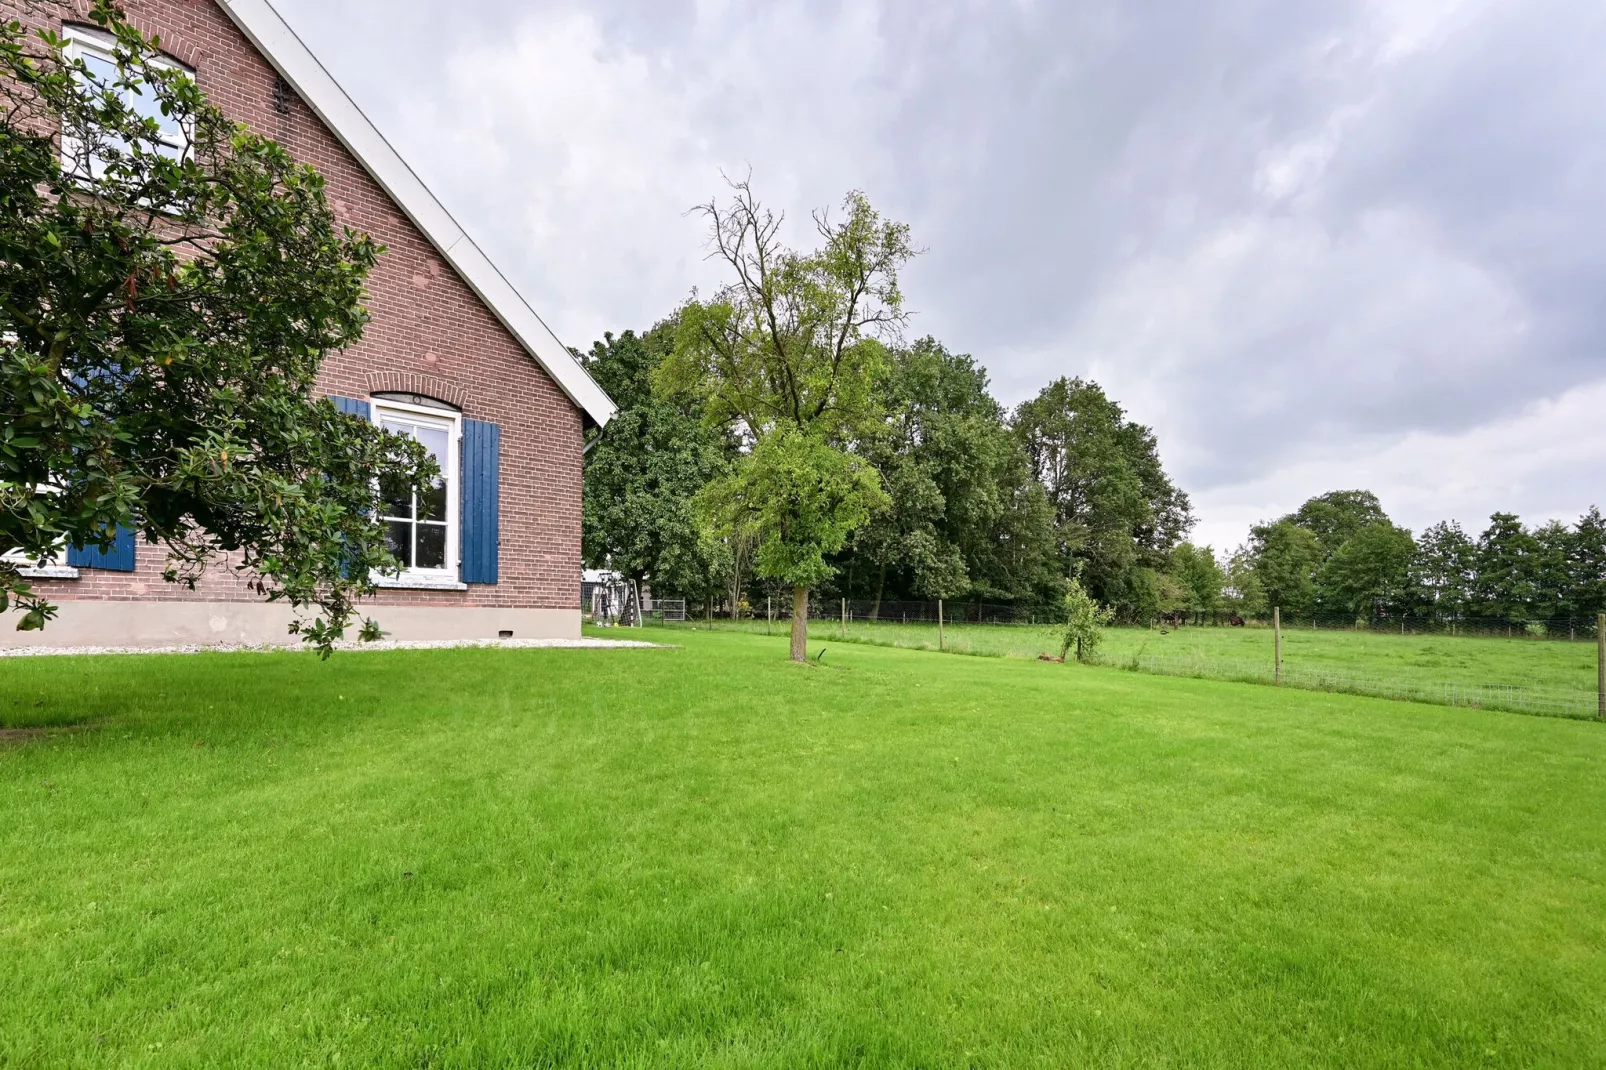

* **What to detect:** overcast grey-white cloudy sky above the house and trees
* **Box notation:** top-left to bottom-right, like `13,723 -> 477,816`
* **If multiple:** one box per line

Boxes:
275,0 -> 1606,549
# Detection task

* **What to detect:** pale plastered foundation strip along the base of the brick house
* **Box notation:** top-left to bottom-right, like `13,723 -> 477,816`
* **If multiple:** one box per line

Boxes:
0,601 -> 580,647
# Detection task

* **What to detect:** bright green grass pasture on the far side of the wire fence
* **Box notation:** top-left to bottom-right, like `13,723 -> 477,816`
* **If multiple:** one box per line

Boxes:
693,620 -> 1596,717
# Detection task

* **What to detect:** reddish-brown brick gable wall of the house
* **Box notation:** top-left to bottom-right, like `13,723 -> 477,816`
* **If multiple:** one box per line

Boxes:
0,0 -> 581,609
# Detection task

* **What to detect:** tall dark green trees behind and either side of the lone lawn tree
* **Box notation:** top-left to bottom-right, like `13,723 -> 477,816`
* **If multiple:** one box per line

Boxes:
583,318 -> 1192,620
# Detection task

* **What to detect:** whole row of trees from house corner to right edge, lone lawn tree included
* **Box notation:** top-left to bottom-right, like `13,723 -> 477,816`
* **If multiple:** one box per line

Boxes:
580,183 -> 1606,642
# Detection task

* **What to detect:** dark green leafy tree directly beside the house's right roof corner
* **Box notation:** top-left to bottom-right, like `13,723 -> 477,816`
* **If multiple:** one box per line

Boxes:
581,321 -> 734,591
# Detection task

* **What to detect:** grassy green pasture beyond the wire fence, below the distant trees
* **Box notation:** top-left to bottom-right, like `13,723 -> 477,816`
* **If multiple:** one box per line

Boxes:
655,598 -> 1606,720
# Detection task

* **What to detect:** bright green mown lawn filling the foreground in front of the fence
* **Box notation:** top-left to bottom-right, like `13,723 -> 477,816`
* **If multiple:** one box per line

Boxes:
0,630 -> 1606,1067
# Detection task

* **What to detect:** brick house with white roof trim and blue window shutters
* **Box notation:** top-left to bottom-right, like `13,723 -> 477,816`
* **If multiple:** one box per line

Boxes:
0,0 -> 613,646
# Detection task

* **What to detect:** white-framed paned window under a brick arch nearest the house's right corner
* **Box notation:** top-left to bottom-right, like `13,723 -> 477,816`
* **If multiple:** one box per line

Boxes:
373,398 -> 463,588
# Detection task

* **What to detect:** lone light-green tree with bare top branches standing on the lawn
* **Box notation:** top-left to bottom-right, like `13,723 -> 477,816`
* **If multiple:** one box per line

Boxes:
658,182 -> 915,660
